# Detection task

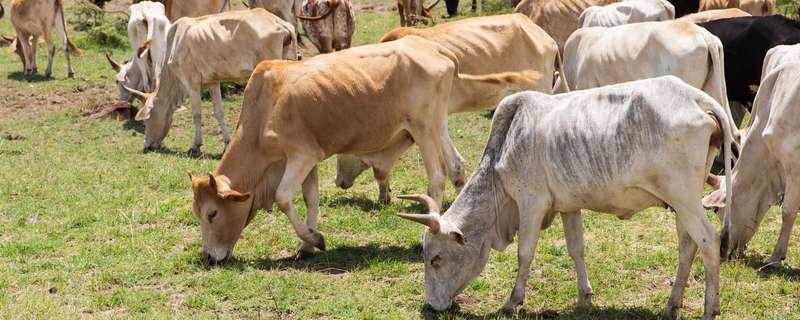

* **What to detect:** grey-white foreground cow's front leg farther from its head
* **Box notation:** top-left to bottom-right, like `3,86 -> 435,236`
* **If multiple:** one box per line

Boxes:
561,211 -> 593,308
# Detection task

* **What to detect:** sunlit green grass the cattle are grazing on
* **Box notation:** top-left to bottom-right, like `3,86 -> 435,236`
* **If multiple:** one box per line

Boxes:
0,2 -> 800,319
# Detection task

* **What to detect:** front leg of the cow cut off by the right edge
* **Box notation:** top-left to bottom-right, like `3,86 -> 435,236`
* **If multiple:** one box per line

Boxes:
767,180 -> 800,266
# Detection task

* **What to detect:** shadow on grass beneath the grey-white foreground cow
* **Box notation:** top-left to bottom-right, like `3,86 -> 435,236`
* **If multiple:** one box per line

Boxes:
420,305 -> 661,320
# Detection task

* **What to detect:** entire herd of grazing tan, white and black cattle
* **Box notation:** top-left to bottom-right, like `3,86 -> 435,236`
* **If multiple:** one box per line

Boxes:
0,0 -> 800,319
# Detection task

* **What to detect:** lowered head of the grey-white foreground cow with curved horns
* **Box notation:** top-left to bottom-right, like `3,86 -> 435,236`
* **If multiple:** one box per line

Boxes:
398,195 -> 491,311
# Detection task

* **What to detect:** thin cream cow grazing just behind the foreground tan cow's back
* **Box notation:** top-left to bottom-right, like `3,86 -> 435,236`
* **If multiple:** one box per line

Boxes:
126,8 -> 298,154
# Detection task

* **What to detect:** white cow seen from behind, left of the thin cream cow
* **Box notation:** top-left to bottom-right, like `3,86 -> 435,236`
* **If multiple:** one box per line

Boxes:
128,1 -> 170,92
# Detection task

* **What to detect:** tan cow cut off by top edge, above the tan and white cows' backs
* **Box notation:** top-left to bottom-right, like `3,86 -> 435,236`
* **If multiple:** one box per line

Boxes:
514,0 -> 618,51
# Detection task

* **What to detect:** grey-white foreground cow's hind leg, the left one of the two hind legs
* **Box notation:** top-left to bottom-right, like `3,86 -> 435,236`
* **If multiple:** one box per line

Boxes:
662,216 -> 697,319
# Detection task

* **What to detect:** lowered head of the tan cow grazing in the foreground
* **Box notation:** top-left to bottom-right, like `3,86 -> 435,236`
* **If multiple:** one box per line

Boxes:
190,173 -> 253,264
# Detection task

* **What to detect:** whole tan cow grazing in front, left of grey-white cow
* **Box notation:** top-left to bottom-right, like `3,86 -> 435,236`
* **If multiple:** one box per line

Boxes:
192,36 -> 544,262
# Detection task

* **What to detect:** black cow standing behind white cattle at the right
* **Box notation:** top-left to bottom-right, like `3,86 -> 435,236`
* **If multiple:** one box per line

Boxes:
698,15 -> 800,125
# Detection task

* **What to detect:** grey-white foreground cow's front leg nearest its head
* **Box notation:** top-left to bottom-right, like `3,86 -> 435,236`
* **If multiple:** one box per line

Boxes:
500,199 -> 548,314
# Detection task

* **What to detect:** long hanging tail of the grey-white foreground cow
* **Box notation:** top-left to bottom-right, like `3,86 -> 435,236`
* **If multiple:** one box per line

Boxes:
706,97 -> 736,258
